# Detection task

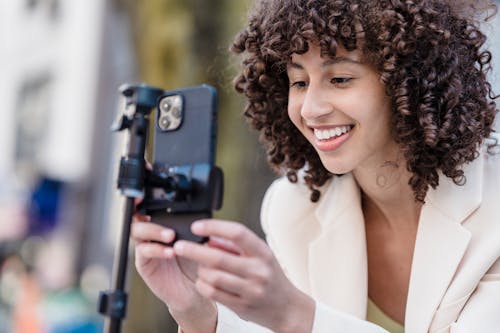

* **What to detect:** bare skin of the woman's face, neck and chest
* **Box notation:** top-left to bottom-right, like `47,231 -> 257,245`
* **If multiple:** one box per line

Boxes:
287,45 -> 421,323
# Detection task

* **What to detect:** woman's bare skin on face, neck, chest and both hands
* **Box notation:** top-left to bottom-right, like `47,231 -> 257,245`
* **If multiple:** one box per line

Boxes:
132,45 -> 421,333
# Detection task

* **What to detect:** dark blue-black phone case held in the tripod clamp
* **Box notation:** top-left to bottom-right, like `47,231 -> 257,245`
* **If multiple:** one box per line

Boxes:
148,85 -> 217,242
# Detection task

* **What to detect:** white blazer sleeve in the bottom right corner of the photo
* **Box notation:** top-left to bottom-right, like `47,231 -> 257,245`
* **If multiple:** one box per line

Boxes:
448,259 -> 500,333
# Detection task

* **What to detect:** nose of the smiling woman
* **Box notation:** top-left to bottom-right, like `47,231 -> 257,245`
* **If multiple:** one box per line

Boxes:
301,84 -> 333,120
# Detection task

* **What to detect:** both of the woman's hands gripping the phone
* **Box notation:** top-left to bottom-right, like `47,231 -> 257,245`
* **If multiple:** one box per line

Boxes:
131,213 -> 314,333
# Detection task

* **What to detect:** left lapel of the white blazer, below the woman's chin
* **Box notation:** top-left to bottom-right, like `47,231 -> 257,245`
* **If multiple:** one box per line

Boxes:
308,174 -> 367,319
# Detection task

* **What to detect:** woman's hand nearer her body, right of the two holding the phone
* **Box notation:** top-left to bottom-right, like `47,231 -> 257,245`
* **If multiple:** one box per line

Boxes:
174,220 -> 315,332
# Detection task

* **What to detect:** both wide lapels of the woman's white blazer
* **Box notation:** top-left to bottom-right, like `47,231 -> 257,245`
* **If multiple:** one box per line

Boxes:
308,157 -> 483,333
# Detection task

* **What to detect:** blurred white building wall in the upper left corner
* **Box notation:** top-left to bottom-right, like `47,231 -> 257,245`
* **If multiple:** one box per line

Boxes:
0,0 -> 104,182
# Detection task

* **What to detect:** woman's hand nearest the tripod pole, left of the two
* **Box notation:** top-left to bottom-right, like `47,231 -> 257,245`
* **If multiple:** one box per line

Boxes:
131,214 -> 217,332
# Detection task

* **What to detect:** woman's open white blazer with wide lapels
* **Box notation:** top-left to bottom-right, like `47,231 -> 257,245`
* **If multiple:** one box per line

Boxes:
217,136 -> 500,333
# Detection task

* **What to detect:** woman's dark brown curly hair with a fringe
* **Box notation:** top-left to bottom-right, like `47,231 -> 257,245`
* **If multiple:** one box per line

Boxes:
231,0 -> 498,202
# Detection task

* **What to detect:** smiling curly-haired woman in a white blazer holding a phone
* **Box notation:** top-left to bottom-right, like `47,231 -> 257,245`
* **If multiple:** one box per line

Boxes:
132,0 -> 500,333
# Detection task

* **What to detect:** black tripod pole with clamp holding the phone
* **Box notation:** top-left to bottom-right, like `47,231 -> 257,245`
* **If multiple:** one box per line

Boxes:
98,84 -> 223,333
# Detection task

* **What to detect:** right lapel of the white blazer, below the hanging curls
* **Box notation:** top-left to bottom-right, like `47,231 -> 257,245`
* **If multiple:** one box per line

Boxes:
405,158 -> 483,333
